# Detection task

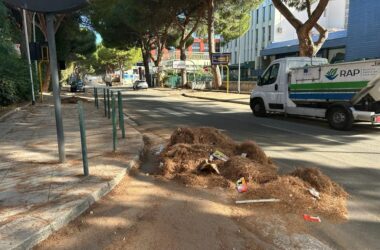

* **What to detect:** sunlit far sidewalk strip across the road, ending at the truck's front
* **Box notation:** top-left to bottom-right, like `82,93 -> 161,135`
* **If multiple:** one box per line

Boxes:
182,91 -> 250,105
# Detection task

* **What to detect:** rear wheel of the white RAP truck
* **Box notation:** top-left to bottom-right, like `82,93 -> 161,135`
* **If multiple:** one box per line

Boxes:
327,106 -> 354,130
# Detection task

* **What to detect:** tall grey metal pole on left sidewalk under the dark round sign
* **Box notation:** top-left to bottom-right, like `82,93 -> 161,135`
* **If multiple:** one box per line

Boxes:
46,13 -> 66,163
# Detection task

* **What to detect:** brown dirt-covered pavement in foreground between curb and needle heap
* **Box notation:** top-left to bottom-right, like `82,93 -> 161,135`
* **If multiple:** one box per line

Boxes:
35,130 -> 340,249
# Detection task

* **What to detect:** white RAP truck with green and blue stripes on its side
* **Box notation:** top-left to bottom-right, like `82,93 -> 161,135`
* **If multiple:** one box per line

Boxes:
250,57 -> 380,130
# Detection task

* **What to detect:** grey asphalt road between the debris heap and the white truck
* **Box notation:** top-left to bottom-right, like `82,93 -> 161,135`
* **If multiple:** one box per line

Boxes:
123,90 -> 380,249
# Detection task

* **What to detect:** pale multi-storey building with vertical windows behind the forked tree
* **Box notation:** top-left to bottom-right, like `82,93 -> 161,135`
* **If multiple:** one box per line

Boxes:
222,0 -> 348,78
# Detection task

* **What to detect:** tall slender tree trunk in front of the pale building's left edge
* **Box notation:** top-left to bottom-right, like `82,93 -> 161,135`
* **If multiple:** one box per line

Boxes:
207,0 -> 222,89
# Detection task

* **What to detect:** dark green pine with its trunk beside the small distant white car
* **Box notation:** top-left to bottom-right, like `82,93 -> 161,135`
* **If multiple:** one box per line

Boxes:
88,0 -> 172,84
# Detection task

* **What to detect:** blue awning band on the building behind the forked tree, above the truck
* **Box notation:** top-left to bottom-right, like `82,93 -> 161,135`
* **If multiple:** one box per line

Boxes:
261,30 -> 347,56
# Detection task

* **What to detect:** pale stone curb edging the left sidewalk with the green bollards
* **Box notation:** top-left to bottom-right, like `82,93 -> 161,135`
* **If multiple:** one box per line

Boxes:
9,132 -> 144,250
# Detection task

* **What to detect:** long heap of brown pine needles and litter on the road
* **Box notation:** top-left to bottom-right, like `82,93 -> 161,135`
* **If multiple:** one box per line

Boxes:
159,127 -> 348,219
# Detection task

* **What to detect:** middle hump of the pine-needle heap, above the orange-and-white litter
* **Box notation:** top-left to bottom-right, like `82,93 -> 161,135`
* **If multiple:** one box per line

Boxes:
220,156 -> 277,184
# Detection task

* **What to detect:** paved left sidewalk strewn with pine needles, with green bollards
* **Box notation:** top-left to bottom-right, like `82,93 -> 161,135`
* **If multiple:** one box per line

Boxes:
0,95 -> 143,249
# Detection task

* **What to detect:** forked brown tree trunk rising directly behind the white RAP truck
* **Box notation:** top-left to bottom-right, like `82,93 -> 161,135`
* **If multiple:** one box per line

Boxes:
272,0 -> 329,57
